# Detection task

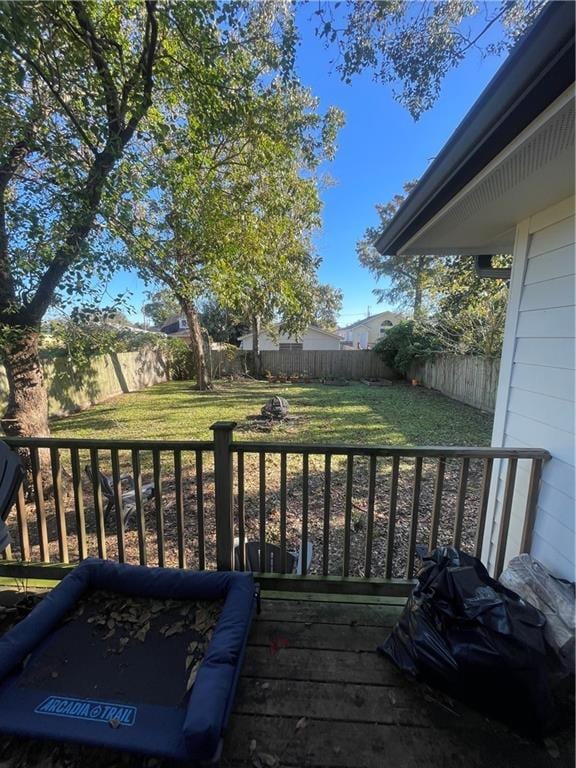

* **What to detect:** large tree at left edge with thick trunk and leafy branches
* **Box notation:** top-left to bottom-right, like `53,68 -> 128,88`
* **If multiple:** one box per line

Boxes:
0,0 -> 160,435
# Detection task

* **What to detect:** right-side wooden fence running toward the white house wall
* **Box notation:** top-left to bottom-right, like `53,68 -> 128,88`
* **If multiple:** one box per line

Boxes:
410,353 -> 500,413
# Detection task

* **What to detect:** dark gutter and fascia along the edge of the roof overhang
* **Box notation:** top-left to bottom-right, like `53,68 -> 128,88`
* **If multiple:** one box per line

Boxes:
375,2 -> 575,254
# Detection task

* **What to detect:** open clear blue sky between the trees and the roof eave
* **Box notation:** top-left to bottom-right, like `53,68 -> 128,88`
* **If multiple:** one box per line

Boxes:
109,3 -> 502,325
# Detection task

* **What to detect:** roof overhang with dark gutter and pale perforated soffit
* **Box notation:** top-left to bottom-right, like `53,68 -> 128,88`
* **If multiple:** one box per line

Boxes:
376,2 -> 574,255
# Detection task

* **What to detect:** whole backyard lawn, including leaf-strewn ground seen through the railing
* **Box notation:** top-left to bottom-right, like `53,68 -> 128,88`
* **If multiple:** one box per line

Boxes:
5,380 -> 491,577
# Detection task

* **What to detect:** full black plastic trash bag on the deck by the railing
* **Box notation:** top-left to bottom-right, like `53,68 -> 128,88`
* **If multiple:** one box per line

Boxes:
378,547 -> 553,735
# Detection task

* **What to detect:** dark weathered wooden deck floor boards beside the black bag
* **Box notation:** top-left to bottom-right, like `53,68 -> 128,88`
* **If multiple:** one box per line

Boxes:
222,595 -> 573,768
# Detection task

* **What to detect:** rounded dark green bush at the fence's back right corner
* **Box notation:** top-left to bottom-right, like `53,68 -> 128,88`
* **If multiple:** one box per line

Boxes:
374,320 -> 442,376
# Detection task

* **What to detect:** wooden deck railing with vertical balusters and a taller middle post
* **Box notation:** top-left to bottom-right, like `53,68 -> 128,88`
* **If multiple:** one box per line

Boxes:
0,422 -> 548,594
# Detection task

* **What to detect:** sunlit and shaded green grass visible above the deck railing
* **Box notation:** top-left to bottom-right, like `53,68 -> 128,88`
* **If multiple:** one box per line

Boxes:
52,381 -> 492,446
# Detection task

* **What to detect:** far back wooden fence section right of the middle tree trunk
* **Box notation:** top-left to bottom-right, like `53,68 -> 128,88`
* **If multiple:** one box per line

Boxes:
260,349 -> 395,380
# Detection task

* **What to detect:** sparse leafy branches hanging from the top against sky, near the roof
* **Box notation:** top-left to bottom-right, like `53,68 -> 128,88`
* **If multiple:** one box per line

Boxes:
316,0 -> 545,120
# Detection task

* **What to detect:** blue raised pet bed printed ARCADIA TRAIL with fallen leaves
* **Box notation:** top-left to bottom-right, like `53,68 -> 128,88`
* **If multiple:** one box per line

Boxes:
0,559 -> 258,761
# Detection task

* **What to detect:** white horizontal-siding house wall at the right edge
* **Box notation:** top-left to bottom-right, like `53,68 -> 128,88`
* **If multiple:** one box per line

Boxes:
483,198 -> 575,580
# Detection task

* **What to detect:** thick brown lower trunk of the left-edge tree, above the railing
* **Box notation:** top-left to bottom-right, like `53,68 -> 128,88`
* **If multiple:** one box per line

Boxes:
1,327 -> 50,437
